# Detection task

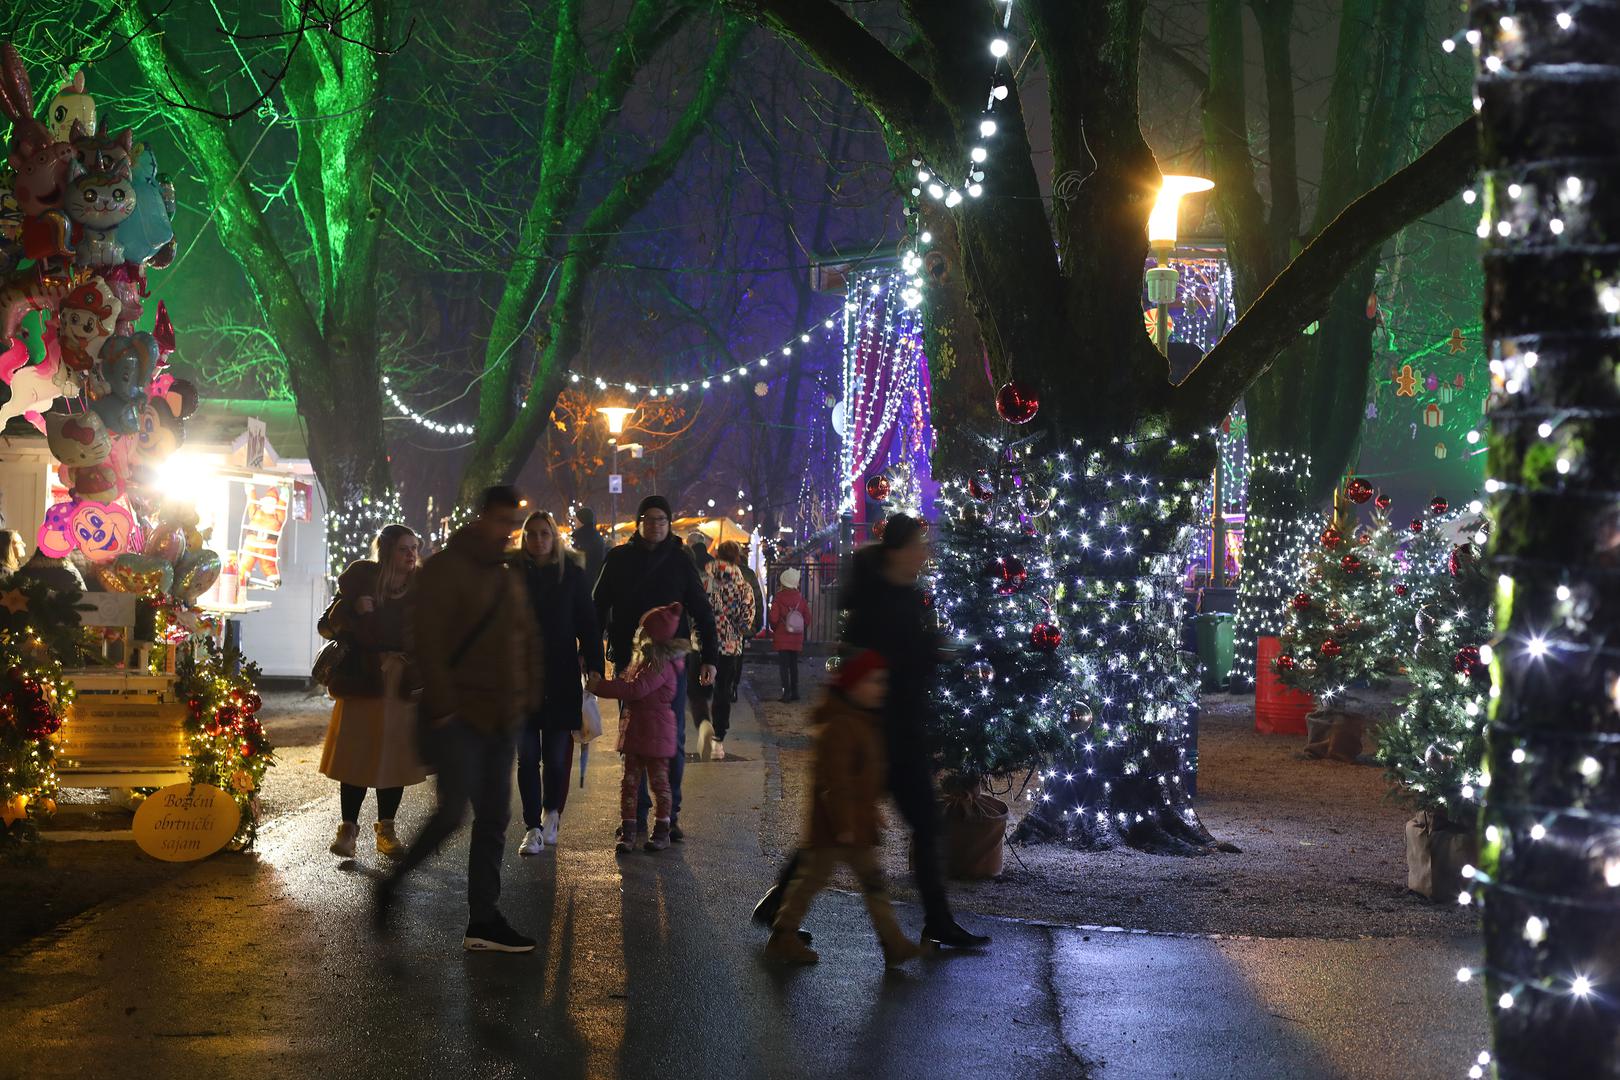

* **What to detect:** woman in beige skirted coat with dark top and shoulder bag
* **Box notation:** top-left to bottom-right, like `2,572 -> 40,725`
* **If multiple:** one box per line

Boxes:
319,525 -> 428,858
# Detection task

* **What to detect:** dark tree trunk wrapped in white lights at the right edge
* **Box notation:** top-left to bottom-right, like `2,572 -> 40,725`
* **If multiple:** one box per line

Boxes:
1461,0 -> 1620,1078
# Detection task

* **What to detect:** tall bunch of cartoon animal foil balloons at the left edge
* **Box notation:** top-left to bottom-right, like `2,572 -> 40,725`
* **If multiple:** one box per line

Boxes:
0,44 -> 219,601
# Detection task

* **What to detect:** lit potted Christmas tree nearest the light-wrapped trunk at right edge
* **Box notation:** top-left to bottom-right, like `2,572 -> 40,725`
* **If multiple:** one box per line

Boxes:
1377,515 -> 1492,829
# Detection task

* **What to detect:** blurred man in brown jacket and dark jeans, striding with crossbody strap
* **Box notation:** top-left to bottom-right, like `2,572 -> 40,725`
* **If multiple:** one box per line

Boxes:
376,486 -> 544,952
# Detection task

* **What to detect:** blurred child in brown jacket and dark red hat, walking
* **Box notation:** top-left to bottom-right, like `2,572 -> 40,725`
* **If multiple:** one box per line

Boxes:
765,651 -> 922,967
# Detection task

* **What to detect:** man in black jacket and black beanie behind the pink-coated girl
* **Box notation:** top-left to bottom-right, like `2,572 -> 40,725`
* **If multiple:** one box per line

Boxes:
593,495 -> 719,840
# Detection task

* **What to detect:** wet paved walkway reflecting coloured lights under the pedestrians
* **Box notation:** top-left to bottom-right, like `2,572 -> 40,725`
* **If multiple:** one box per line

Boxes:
0,689 -> 1486,1080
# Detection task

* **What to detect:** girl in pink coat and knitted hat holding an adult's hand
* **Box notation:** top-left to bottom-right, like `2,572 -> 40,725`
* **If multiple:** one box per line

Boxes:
590,604 -> 687,852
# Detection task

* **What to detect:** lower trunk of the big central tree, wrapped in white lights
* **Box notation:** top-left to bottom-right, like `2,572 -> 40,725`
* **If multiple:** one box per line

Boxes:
1019,434 -> 1234,853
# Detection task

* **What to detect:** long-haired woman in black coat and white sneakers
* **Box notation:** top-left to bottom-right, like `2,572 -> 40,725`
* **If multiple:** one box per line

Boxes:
517,510 -> 606,855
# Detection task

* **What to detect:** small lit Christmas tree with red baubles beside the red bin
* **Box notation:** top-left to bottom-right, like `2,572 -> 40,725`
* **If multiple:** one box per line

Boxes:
1275,501 -> 1396,701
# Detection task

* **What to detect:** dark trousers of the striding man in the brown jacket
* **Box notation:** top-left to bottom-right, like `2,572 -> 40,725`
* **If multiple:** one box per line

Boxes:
387,717 -> 514,923
